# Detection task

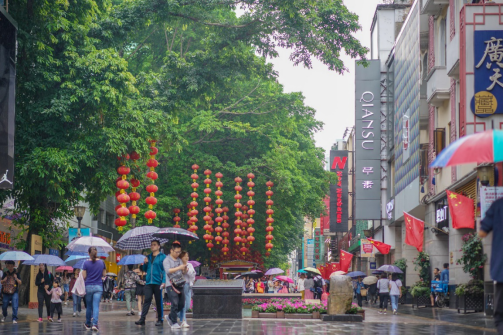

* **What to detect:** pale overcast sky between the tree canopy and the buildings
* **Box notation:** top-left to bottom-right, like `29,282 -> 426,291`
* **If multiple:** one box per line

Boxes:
269,0 -> 382,153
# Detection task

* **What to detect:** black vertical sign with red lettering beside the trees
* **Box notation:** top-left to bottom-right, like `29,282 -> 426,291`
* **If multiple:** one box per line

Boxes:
330,150 -> 349,232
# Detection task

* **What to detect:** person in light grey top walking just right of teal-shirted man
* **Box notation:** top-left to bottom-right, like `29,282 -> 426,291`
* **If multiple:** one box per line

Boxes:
164,242 -> 188,330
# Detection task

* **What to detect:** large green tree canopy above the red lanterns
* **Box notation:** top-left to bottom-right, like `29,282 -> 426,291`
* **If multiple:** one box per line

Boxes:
2,0 -> 367,270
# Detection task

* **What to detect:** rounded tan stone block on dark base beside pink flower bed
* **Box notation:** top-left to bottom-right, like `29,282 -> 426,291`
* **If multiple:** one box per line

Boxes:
327,274 -> 353,315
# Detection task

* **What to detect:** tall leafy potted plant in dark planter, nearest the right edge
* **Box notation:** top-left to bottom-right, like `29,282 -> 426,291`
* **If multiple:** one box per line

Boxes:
456,233 -> 487,314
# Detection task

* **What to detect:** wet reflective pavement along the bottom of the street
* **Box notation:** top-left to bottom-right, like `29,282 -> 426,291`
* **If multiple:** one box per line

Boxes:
0,302 -> 495,335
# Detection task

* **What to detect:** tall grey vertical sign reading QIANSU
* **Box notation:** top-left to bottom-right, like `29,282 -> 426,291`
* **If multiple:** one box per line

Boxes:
355,60 -> 381,220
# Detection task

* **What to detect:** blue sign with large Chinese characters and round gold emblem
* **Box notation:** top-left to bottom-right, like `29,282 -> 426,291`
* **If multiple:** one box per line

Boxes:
471,30 -> 503,118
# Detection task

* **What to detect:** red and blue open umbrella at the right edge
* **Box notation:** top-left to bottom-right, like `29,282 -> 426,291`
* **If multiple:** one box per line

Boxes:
430,130 -> 503,168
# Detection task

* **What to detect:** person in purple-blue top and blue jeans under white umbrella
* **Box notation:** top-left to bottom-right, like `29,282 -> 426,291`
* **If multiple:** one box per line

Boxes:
82,247 -> 107,332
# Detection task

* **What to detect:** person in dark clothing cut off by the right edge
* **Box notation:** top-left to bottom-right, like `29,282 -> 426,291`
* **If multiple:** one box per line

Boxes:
479,199 -> 503,335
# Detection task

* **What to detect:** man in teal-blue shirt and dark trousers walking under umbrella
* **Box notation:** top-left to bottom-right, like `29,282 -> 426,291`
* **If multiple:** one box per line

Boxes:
135,240 -> 166,327
